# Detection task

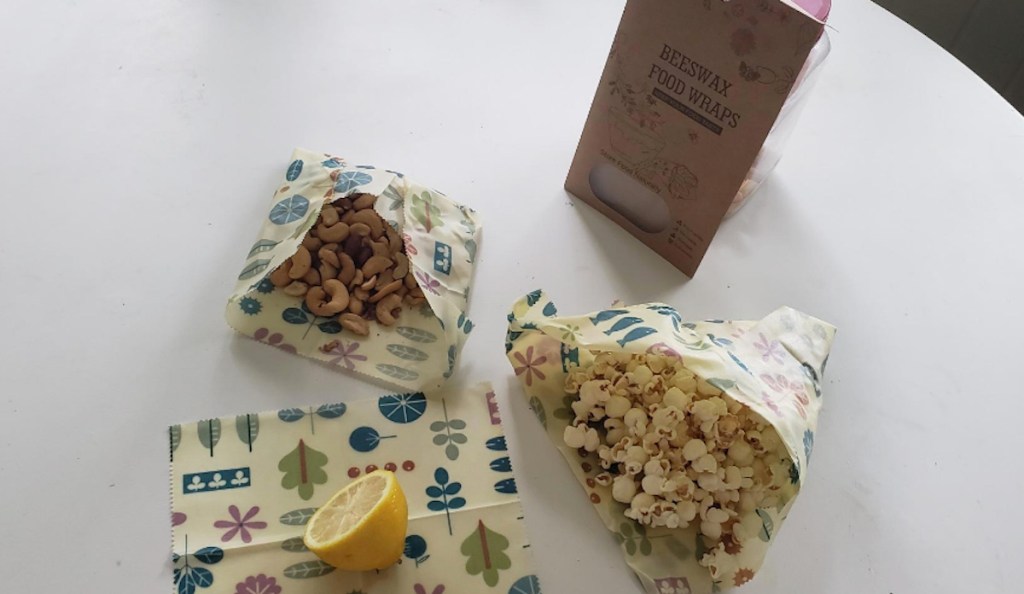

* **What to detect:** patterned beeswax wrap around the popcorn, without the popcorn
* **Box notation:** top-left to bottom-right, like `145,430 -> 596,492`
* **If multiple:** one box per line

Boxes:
505,291 -> 836,594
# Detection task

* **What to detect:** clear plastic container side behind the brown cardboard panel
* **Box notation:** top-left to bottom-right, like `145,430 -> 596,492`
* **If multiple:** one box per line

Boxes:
725,0 -> 831,216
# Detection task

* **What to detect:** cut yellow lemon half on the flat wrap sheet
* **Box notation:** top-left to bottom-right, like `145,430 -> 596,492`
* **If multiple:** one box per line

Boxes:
302,470 -> 409,571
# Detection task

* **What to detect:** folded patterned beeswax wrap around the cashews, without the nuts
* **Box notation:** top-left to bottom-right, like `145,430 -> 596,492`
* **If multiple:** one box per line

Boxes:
225,150 -> 480,390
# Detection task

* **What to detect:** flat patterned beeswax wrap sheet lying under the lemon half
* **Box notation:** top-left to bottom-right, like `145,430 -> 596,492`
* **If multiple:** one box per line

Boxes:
170,384 -> 541,594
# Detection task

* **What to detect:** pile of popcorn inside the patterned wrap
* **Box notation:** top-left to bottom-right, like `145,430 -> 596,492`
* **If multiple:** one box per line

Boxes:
563,352 -> 790,561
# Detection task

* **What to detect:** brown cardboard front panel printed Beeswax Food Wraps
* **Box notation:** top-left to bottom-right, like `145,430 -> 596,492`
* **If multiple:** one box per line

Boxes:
565,0 -> 824,277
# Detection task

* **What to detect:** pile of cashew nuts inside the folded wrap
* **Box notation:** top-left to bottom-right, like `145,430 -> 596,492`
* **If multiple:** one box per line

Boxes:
269,194 -> 426,336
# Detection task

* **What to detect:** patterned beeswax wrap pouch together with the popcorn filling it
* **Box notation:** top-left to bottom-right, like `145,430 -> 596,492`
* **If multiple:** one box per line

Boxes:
505,291 -> 836,594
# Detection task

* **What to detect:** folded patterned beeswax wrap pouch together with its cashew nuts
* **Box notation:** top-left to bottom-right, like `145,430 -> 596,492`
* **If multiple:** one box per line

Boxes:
225,150 -> 480,390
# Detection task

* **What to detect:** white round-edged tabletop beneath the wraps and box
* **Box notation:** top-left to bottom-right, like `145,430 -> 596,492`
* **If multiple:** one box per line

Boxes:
0,0 -> 1024,594
